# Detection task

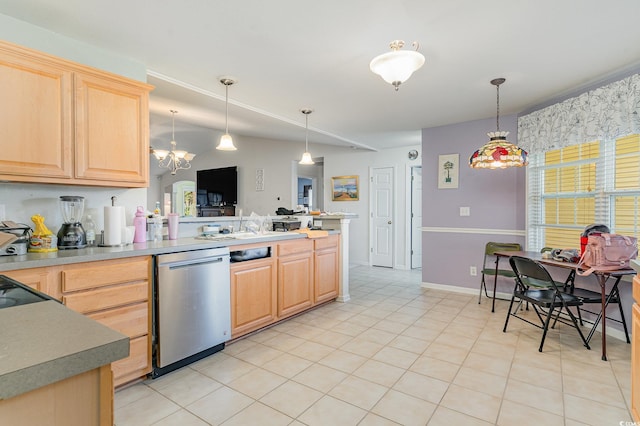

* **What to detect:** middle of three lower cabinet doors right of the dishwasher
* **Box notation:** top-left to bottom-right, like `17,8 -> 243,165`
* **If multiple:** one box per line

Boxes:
278,239 -> 313,318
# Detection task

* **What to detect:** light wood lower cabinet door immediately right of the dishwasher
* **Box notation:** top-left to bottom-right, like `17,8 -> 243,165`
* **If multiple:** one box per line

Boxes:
231,258 -> 278,338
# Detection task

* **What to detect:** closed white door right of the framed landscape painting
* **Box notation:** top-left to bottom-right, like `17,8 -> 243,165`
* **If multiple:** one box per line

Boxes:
371,167 -> 394,268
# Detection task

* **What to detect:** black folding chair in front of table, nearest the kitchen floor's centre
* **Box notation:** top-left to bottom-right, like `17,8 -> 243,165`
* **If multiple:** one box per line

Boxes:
502,256 -> 591,352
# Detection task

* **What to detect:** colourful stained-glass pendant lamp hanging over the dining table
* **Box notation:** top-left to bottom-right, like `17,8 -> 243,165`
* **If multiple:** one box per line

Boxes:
469,78 -> 529,169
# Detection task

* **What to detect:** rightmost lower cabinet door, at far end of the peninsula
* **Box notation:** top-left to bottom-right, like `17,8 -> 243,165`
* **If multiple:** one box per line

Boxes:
313,235 -> 340,304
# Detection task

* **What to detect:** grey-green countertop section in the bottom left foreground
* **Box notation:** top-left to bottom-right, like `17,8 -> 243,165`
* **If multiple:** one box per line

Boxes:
0,300 -> 129,399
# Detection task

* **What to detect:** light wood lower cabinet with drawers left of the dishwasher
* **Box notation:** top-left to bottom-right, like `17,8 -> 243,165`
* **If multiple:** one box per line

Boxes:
1,256 -> 152,386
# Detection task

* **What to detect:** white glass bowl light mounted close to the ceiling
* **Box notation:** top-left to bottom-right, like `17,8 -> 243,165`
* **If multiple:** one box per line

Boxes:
369,40 -> 424,91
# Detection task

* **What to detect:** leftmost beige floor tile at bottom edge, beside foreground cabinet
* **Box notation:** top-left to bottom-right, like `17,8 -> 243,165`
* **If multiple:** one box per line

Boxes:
114,391 -> 180,426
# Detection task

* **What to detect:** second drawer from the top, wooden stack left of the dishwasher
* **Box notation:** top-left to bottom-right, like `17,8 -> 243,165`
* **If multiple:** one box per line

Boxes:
62,281 -> 149,314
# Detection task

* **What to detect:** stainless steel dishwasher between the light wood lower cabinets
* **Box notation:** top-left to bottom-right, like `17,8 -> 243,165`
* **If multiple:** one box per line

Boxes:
152,247 -> 231,377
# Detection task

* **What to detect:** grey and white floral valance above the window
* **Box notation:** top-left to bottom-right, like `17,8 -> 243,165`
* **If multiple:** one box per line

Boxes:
518,74 -> 640,154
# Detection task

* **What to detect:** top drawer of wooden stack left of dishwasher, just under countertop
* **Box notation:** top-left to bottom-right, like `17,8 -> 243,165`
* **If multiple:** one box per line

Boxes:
62,257 -> 150,292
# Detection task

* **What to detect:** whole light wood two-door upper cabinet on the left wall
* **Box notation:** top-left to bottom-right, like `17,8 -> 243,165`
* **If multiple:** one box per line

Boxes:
0,41 -> 152,188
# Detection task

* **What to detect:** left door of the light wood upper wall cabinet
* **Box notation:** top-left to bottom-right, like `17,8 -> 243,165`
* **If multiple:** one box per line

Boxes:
0,43 -> 73,183
